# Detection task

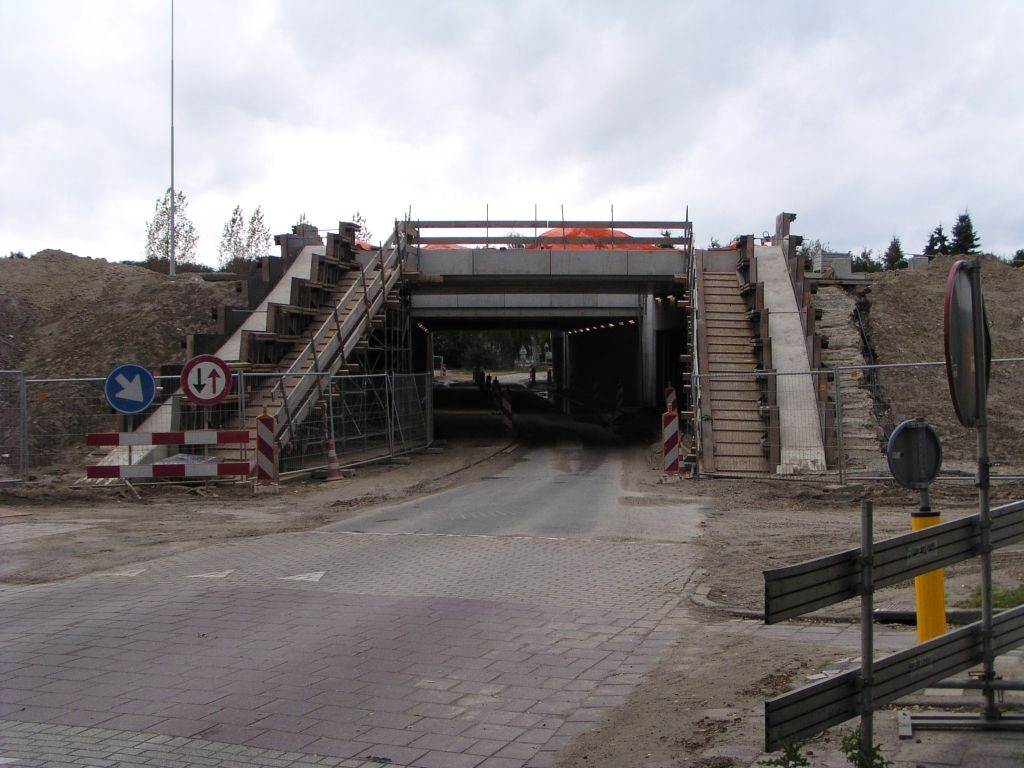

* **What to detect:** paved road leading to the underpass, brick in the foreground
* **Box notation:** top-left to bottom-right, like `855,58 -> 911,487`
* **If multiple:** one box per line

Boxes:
0,442 -> 698,768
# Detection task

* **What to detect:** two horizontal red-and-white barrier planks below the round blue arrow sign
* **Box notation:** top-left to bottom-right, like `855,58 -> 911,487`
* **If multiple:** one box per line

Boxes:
85,429 -> 252,480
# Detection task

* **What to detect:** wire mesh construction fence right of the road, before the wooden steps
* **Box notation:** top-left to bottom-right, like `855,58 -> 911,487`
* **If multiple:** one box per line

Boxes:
693,358 -> 1024,482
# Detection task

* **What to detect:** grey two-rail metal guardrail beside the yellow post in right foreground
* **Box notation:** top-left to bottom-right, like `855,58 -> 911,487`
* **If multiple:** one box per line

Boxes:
764,501 -> 1024,752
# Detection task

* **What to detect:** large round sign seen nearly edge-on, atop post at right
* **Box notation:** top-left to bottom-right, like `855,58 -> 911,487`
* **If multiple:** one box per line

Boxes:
942,259 -> 992,427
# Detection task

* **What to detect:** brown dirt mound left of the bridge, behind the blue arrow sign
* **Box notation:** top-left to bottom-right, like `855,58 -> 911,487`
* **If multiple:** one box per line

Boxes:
0,250 -> 236,378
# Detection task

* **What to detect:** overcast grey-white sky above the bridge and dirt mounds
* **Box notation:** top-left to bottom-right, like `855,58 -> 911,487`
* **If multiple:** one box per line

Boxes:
0,0 -> 1024,264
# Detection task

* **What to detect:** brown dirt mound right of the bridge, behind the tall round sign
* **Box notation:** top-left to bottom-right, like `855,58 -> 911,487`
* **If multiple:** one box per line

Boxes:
866,256 -> 1024,466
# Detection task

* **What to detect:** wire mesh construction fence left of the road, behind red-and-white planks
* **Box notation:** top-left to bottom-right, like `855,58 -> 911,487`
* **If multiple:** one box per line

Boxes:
0,371 -> 433,482
